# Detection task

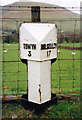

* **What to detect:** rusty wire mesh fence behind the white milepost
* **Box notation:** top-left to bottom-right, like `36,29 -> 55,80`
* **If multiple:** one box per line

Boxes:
0,5 -> 82,99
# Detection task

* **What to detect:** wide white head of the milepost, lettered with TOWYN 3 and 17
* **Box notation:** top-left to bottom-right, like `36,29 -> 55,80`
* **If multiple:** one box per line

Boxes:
20,23 -> 57,61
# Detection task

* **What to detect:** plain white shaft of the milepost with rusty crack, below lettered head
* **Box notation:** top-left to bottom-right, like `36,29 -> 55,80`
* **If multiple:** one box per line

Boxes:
28,60 -> 51,104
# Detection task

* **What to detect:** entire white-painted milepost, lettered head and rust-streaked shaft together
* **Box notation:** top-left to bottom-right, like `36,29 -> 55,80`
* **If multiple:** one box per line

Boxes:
20,23 -> 57,104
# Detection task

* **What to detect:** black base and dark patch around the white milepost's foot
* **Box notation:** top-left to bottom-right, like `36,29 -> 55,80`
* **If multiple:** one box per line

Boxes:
21,94 -> 57,115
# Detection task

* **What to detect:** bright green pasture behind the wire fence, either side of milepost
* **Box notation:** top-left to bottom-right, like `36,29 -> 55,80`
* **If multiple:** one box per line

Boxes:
2,44 -> 80,95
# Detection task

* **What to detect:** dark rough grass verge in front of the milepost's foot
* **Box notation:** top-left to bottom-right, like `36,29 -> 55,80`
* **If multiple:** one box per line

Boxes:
2,99 -> 81,119
